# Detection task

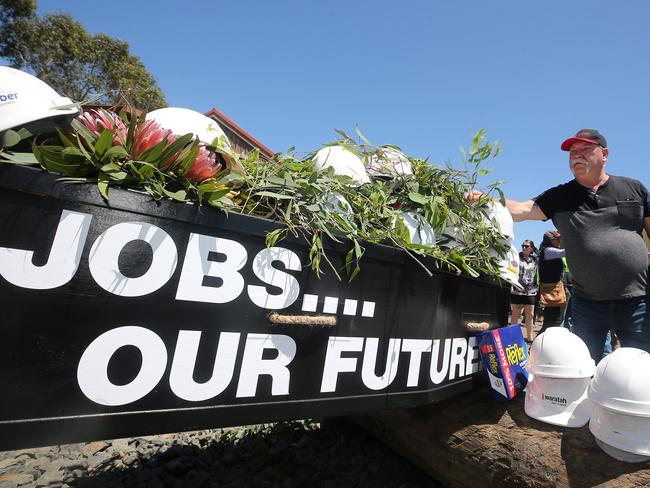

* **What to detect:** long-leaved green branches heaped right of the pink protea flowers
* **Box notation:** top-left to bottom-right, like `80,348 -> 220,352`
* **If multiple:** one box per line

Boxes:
235,131 -> 507,280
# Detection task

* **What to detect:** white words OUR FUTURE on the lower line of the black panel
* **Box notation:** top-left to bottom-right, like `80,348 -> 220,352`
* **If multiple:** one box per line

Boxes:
77,326 -> 479,406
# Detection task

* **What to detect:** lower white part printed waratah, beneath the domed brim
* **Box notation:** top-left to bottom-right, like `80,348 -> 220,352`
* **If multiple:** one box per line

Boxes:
524,375 -> 592,427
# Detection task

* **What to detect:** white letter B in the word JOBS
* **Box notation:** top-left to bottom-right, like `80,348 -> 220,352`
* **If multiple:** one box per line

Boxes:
176,233 -> 248,303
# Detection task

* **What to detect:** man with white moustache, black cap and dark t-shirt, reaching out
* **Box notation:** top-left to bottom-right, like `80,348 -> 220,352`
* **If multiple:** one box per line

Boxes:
467,129 -> 650,361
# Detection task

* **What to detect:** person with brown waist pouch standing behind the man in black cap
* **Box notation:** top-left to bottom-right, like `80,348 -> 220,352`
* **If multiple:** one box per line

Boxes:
537,230 -> 566,334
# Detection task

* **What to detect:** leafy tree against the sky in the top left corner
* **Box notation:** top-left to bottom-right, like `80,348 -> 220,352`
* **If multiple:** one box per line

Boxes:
0,0 -> 167,110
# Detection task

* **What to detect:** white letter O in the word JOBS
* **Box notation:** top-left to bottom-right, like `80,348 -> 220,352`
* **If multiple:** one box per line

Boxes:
88,222 -> 178,297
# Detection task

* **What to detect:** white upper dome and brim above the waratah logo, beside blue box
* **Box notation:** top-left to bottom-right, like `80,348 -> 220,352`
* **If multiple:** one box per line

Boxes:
526,327 -> 596,378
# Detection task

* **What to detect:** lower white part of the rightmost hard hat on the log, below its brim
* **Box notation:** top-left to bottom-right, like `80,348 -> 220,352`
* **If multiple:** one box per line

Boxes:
589,405 -> 650,460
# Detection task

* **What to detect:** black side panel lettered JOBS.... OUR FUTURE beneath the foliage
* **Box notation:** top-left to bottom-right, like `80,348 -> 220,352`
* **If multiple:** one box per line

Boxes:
0,166 -> 508,449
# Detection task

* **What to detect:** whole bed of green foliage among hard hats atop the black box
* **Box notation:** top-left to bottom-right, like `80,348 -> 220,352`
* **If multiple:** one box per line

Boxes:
0,108 -> 508,280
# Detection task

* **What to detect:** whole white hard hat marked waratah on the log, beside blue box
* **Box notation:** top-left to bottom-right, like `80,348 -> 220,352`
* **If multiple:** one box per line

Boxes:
524,327 -> 595,427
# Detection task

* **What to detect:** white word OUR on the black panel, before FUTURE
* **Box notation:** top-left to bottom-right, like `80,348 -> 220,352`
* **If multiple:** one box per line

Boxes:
77,326 -> 296,406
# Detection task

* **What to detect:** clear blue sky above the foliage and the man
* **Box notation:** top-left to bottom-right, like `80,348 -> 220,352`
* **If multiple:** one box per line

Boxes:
38,0 -> 650,245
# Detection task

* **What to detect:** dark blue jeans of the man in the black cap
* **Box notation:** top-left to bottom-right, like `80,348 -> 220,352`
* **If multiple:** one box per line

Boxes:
571,296 -> 650,362
